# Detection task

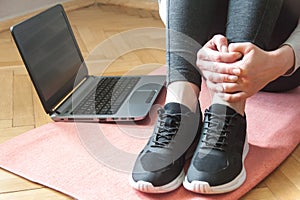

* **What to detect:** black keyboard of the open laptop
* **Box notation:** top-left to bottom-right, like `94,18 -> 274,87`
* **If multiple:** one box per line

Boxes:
73,77 -> 140,115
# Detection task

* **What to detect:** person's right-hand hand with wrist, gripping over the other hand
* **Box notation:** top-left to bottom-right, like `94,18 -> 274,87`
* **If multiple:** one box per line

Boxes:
215,43 -> 294,102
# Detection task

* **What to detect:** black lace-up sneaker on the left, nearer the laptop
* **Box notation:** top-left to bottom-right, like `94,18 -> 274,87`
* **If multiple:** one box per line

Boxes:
130,103 -> 202,193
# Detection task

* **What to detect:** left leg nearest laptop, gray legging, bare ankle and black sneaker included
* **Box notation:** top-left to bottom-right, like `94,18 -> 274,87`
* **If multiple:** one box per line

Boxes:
130,0 -> 227,193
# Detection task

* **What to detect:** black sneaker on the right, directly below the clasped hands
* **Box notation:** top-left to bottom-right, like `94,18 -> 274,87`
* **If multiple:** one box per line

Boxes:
183,104 -> 249,194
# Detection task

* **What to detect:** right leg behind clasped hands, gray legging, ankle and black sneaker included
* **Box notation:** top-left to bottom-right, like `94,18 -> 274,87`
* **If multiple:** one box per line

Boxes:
183,0 -> 281,194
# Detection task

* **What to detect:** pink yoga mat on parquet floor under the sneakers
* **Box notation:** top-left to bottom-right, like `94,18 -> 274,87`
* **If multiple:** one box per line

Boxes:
0,83 -> 300,200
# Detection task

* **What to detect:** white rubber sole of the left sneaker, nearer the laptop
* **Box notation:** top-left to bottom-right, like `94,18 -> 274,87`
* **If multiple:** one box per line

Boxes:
129,170 -> 185,193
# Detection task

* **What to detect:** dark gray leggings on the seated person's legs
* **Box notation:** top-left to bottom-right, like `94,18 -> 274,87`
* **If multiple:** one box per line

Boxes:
166,0 -> 300,92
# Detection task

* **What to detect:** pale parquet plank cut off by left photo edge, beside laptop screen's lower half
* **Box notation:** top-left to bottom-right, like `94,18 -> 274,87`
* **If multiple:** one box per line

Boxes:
0,70 -> 13,120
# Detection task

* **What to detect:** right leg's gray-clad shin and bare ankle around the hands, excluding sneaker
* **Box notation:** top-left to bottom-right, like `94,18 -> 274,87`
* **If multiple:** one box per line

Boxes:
213,0 -> 282,115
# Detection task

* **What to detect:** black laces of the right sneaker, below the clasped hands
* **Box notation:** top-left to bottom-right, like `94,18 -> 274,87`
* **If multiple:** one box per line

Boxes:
201,111 -> 231,151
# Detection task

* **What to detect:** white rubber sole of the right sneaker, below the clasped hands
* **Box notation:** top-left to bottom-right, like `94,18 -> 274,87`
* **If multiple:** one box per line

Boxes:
183,138 -> 249,194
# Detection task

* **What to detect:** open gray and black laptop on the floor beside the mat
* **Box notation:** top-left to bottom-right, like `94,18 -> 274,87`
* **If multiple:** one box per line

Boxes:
11,4 -> 166,122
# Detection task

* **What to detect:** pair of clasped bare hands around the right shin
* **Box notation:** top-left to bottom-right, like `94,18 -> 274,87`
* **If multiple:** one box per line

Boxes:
196,35 -> 293,102
